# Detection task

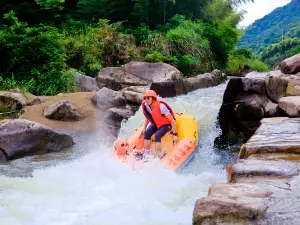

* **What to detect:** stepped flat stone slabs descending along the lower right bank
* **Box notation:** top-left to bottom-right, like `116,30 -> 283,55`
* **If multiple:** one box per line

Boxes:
193,117 -> 300,225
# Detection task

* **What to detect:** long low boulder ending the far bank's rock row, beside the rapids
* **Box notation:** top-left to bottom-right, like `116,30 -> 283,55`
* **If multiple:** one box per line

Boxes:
183,70 -> 226,92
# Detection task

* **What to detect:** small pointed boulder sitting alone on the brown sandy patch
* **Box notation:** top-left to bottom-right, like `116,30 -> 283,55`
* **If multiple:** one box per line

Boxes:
44,99 -> 84,121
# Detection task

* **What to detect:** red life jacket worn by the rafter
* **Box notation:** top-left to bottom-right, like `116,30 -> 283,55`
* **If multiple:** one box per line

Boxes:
142,100 -> 175,129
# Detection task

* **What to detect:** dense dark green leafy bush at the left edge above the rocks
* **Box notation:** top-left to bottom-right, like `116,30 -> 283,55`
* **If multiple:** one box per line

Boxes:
0,12 -> 75,95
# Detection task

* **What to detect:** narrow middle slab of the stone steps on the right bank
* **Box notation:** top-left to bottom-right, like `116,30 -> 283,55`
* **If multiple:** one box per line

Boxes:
227,159 -> 300,182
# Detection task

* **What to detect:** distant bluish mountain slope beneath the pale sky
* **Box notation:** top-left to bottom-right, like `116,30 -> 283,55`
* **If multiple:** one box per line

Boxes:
238,0 -> 300,53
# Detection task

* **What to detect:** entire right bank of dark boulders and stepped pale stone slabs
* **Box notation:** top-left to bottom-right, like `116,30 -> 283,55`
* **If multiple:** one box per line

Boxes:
193,54 -> 300,225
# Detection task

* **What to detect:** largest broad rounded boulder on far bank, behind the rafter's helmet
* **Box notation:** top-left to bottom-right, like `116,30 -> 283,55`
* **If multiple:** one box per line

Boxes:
96,61 -> 184,97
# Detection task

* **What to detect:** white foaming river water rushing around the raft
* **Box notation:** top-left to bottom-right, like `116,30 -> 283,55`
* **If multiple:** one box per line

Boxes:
0,84 -> 234,225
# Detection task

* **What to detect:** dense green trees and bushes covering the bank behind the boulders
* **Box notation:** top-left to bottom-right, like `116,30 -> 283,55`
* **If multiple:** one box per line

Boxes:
0,0 -> 267,95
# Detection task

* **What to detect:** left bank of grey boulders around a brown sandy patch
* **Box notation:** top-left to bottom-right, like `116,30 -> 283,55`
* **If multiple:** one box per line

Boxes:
0,61 -> 226,161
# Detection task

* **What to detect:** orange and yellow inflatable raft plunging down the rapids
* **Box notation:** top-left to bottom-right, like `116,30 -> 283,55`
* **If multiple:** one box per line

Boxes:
114,113 -> 198,170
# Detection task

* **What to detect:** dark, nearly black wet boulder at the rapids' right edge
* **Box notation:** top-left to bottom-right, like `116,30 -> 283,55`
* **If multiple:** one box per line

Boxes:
219,78 -> 269,139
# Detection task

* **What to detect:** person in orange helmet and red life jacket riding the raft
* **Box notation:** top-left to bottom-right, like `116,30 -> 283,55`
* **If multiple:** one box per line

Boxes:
142,90 -> 178,156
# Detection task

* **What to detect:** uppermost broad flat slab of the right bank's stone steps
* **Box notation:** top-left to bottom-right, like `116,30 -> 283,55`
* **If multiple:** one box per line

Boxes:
239,117 -> 300,159
